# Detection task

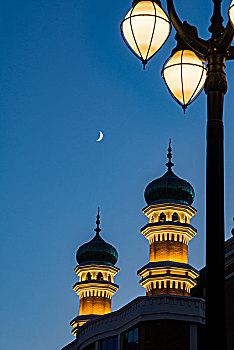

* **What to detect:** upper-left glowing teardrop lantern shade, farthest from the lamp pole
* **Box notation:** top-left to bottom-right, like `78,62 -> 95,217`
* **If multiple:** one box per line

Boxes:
121,1 -> 171,64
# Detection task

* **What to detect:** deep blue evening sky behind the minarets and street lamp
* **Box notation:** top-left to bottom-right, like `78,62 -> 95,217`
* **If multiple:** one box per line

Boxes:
0,0 -> 234,350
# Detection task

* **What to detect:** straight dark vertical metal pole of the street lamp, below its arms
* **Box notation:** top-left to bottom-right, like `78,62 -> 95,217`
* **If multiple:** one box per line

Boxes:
205,53 -> 227,350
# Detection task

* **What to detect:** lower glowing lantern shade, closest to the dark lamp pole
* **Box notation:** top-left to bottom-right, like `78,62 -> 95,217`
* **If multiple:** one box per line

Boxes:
162,50 -> 206,109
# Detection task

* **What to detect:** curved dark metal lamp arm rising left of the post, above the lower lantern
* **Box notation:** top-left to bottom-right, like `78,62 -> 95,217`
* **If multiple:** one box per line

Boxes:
167,0 -> 209,56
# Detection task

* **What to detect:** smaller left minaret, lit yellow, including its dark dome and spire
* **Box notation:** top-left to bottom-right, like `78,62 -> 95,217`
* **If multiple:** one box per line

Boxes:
70,209 -> 119,335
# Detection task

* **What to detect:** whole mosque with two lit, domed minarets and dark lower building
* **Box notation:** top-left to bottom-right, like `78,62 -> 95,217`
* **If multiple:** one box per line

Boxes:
62,144 -> 234,350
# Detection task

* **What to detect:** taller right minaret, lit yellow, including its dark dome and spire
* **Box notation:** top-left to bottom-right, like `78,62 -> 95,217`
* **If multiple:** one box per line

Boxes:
138,140 -> 198,296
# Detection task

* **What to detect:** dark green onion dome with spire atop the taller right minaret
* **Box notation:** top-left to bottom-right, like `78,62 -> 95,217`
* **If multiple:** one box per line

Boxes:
145,140 -> 195,205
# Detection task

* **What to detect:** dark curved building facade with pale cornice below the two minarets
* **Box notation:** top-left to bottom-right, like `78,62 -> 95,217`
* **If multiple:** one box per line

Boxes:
63,295 -> 205,350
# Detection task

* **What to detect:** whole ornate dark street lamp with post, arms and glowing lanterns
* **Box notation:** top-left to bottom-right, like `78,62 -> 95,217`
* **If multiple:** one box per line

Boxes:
121,0 -> 234,350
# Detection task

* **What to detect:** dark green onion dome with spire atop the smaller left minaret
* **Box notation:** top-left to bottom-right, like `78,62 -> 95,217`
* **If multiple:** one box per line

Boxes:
76,208 -> 118,266
